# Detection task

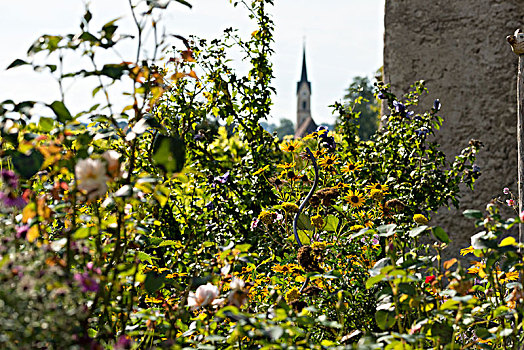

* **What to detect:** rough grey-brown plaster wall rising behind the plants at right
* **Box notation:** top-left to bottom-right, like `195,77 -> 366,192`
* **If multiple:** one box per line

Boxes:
384,0 -> 524,255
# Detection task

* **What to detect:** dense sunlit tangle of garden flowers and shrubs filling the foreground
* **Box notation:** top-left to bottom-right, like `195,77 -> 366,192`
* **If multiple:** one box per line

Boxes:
0,0 -> 523,349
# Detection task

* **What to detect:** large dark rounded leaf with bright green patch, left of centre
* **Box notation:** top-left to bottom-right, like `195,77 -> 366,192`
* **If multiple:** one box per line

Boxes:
152,135 -> 186,173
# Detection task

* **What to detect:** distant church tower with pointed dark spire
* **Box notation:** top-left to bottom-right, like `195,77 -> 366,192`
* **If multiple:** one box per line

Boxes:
295,47 -> 317,137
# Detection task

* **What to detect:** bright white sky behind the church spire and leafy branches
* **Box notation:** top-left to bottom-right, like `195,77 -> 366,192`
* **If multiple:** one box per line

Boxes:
0,0 -> 385,124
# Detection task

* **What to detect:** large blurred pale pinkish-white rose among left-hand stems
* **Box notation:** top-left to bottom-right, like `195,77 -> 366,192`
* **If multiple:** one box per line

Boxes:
75,158 -> 109,200
